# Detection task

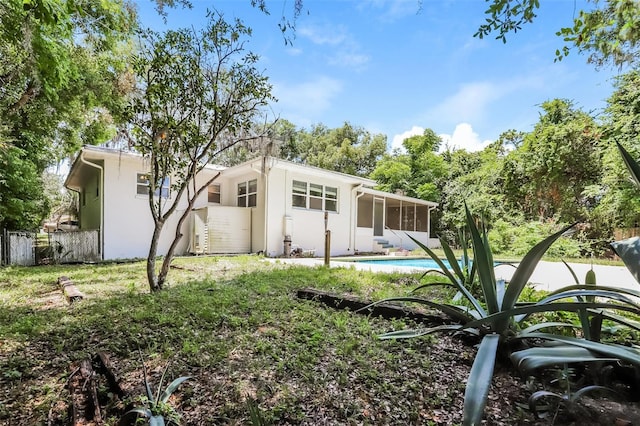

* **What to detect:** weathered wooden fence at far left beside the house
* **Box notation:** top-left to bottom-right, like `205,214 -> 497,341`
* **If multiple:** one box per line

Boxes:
0,230 -> 101,266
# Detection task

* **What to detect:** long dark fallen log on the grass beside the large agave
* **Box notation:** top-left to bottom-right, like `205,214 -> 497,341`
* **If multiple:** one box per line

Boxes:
297,288 -> 451,325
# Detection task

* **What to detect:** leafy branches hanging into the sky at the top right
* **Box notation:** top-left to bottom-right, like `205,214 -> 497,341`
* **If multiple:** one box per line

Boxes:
474,0 -> 640,66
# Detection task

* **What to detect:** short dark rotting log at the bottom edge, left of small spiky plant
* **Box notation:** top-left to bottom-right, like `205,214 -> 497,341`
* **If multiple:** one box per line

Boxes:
69,360 -> 102,426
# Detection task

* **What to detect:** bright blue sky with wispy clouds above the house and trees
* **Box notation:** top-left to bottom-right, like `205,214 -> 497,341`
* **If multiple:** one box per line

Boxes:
138,0 -> 617,150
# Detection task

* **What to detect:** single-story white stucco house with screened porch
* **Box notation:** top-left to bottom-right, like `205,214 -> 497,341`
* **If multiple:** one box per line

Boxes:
65,146 -> 437,259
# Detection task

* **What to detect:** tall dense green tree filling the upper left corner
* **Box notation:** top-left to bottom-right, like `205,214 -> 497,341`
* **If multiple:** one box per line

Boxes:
0,0 -> 135,228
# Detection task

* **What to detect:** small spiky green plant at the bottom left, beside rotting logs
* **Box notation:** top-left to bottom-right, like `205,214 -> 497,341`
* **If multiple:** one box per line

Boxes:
120,362 -> 191,426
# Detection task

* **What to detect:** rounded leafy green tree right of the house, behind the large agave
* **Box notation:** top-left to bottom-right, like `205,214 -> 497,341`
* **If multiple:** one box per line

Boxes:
502,99 -> 601,223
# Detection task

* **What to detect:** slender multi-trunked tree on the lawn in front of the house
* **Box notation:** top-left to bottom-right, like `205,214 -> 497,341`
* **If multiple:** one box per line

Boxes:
127,13 -> 272,292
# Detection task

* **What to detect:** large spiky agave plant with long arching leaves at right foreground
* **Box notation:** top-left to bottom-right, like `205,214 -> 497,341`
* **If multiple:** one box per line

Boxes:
368,206 -> 640,425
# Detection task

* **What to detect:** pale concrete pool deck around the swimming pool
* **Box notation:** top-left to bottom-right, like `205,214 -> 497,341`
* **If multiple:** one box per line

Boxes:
265,258 -> 640,291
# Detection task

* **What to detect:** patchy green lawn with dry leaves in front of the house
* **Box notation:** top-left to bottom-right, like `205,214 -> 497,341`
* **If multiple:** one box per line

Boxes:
0,256 -> 519,425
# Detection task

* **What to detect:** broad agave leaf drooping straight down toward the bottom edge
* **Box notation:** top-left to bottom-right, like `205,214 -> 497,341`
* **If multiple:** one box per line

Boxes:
463,334 -> 500,426
